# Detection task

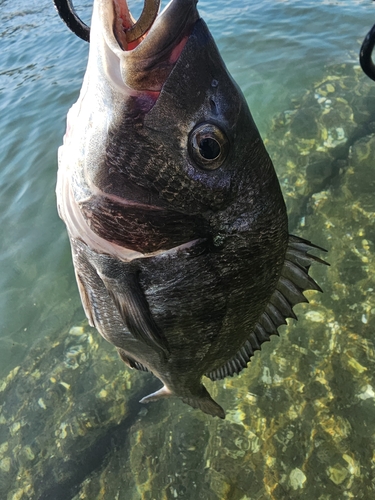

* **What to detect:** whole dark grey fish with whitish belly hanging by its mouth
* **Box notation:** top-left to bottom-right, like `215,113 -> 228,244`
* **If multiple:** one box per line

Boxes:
56,0 -> 324,418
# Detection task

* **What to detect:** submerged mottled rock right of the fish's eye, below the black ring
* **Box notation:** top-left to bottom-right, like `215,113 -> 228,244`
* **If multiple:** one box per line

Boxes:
265,64 -> 375,229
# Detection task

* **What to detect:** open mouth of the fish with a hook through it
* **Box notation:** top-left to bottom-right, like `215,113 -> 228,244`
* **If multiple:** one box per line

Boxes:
97,0 -> 199,92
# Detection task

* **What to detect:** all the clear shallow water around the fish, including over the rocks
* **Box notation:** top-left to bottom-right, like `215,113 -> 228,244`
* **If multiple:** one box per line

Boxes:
0,0 -> 375,500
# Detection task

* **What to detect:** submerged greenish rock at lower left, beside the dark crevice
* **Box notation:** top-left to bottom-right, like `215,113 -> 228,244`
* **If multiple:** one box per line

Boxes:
0,326 -> 157,500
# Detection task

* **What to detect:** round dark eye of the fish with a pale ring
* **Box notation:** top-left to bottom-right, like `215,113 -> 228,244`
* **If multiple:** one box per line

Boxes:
188,123 -> 229,170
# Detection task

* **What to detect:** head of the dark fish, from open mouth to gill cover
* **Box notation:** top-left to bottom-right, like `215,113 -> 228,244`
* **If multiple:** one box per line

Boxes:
61,0 -> 283,253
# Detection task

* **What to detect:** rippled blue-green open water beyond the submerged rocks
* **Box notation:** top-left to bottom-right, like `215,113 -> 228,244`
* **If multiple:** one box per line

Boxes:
0,0 -> 375,499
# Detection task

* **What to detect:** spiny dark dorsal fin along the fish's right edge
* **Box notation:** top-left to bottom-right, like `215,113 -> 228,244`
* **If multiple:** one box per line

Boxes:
207,235 -> 329,380
